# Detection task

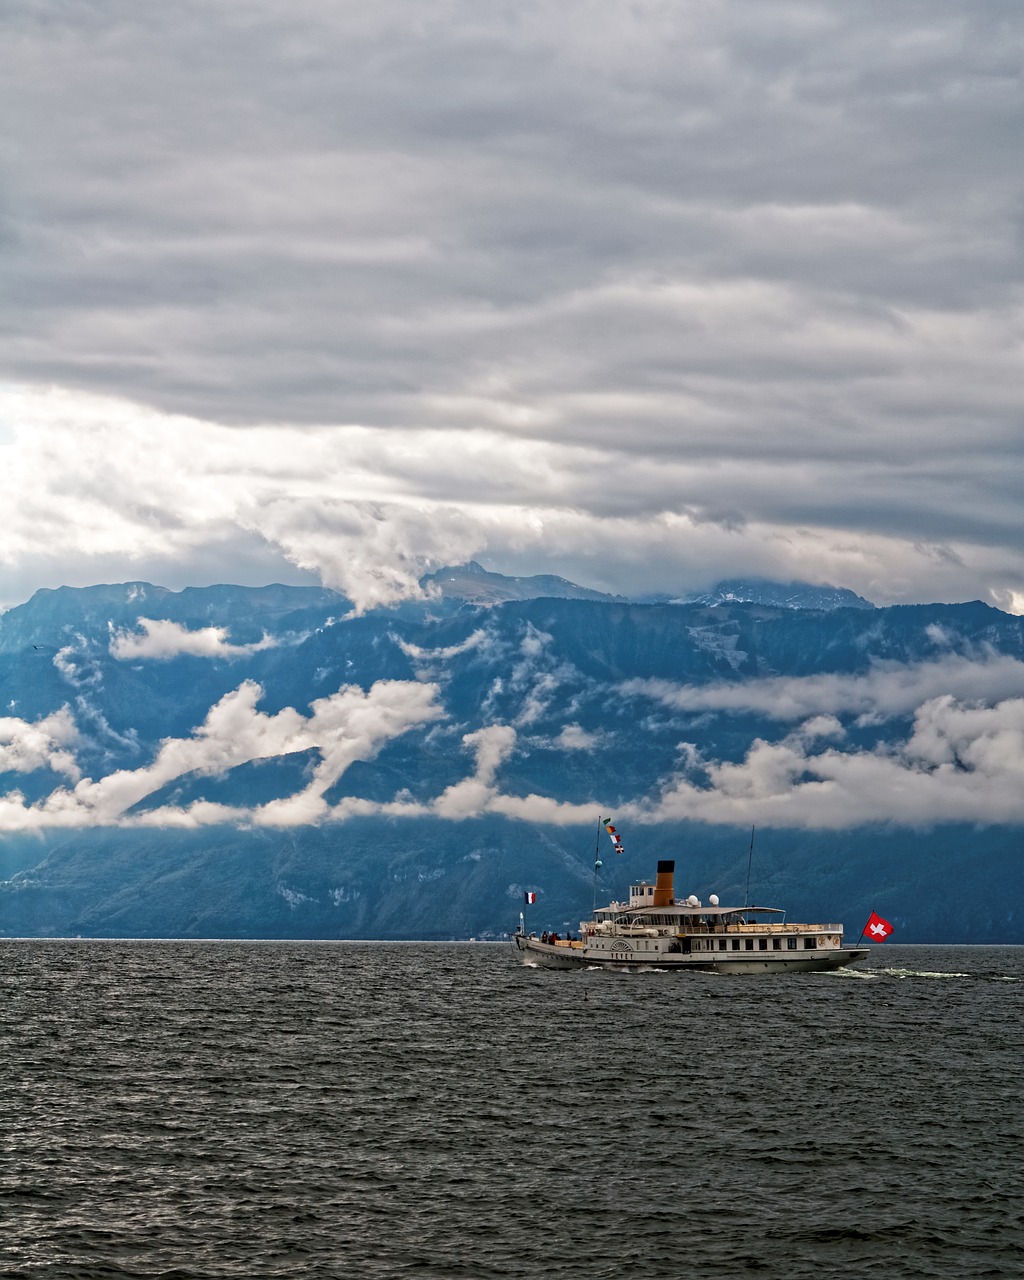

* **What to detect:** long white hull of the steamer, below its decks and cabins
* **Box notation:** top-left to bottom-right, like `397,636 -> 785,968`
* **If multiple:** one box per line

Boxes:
512,933 -> 868,974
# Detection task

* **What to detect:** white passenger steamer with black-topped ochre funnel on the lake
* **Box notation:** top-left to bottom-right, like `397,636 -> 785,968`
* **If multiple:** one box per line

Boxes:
512,860 -> 868,974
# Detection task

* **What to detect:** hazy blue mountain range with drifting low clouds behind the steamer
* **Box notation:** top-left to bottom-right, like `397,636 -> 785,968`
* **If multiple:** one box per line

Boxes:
0,564 -> 1024,942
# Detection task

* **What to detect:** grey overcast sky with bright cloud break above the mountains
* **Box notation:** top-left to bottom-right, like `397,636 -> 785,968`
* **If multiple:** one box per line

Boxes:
0,0 -> 1024,612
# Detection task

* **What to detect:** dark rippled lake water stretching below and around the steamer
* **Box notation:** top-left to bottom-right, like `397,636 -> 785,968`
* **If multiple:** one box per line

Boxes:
0,941 -> 1024,1280
